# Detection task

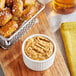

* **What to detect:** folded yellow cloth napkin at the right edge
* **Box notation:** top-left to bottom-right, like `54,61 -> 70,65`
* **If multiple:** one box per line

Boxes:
61,22 -> 76,76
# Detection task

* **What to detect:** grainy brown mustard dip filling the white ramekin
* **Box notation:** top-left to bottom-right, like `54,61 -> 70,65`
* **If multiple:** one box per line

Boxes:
24,36 -> 54,61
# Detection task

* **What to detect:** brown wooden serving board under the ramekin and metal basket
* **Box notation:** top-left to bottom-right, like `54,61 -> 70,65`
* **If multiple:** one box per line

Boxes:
0,11 -> 70,76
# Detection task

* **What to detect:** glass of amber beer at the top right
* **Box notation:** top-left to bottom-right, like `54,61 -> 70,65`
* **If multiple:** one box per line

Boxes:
53,0 -> 76,14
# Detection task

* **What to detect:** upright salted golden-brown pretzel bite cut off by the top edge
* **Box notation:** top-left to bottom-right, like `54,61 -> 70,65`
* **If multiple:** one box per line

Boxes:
12,0 -> 23,17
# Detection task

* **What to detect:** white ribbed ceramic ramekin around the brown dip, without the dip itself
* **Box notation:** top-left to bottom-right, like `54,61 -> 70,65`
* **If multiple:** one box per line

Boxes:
22,34 -> 56,71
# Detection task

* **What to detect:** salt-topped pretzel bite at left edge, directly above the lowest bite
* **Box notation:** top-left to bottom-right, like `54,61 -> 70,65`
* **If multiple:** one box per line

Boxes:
0,8 -> 12,26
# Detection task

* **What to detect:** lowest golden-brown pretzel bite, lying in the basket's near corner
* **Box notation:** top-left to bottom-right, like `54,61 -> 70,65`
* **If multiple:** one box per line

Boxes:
0,20 -> 18,37
